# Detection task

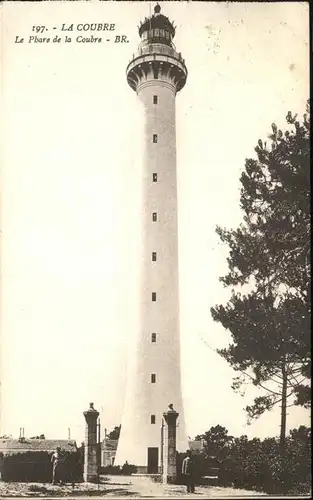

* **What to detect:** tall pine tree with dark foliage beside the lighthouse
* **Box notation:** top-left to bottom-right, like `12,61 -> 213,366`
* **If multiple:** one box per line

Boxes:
211,103 -> 311,432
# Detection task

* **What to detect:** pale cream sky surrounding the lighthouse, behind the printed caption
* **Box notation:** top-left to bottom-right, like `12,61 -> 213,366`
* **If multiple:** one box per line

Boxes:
0,1 -> 309,442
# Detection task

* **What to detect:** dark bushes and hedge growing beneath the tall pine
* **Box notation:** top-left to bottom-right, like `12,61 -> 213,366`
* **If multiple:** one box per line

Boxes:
193,426 -> 311,495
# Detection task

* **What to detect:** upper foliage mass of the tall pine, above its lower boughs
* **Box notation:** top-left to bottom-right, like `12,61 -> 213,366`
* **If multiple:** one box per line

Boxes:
217,103 -> 310,300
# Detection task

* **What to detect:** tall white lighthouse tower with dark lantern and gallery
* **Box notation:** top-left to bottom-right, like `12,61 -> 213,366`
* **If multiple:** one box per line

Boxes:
115,4 -> 188,474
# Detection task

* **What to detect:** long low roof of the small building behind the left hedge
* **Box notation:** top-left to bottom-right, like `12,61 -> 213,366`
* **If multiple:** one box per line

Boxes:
0,438 -> 77,453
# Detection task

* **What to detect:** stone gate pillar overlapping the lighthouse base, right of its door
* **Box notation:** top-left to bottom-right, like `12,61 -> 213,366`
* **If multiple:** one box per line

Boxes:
162,404 -> 179,483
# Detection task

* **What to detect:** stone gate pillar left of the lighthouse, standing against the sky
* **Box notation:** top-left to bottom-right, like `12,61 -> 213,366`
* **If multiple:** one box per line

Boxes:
84,403 -> 99,482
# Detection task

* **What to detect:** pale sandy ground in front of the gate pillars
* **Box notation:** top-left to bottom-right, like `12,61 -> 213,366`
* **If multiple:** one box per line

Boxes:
0,476 -> 261,500
